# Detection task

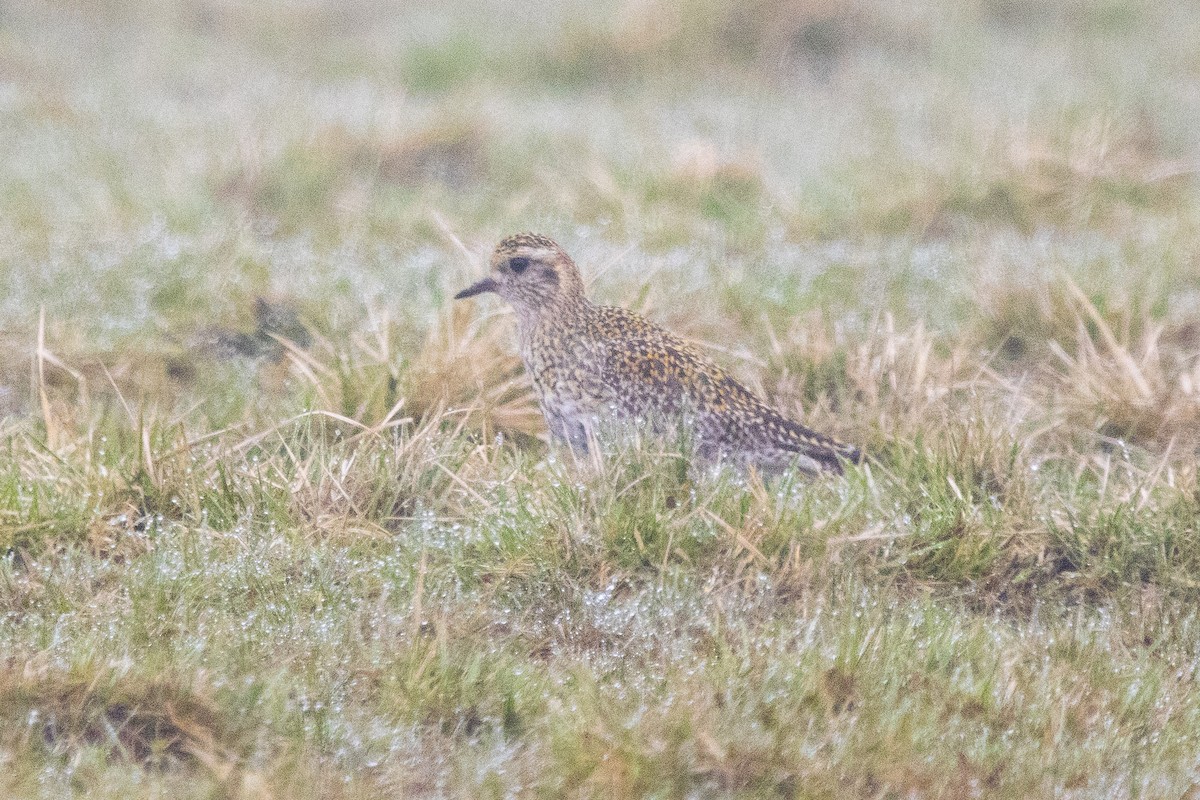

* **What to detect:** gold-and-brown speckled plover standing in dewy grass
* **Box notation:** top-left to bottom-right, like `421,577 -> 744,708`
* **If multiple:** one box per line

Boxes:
455,233 -> 862,474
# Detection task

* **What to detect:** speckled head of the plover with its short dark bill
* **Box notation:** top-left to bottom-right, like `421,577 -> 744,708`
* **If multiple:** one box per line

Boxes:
455,234 -> 583,317
